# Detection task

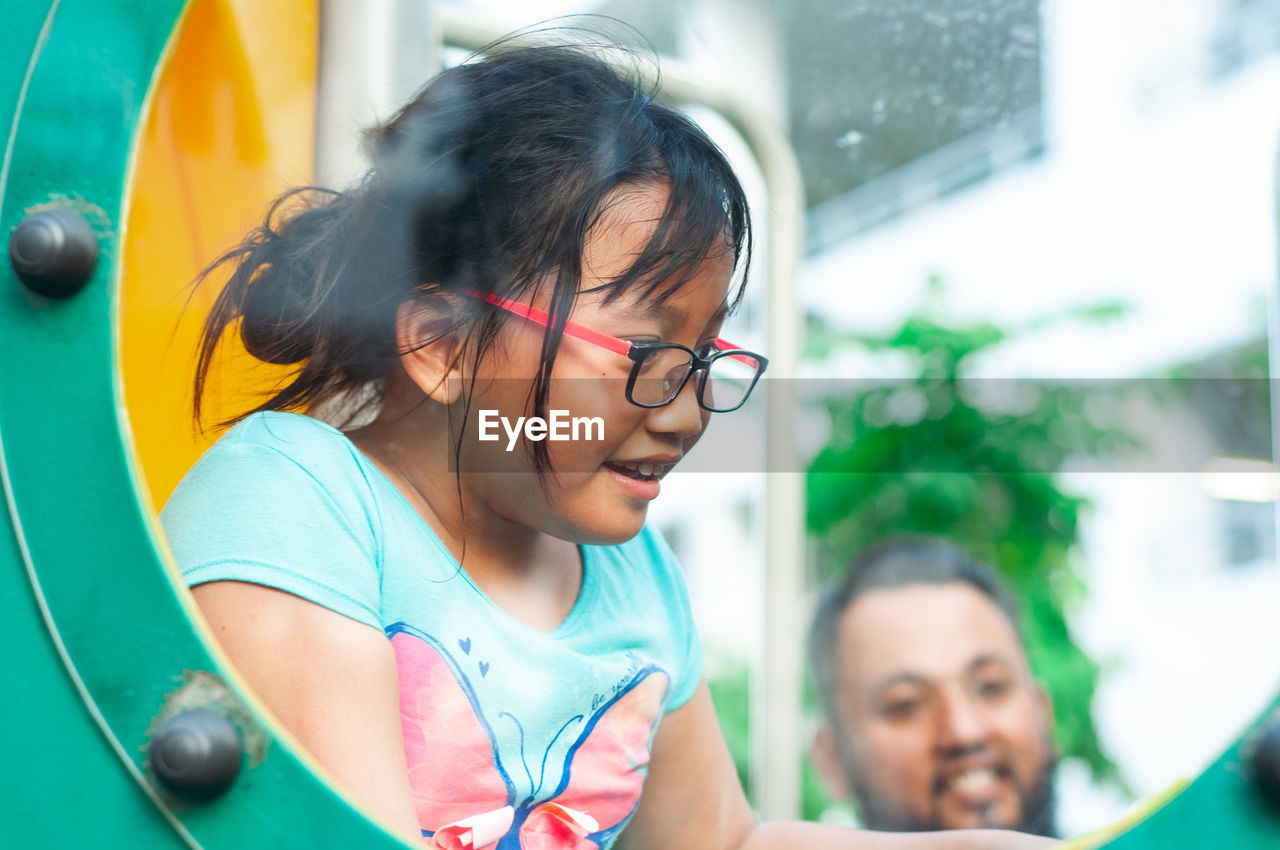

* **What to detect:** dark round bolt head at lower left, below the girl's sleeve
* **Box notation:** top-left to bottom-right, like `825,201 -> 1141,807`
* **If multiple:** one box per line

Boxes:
150,708 -> 244,800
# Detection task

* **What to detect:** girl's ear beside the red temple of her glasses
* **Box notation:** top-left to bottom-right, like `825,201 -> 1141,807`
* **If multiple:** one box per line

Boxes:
396,298 -> 462,405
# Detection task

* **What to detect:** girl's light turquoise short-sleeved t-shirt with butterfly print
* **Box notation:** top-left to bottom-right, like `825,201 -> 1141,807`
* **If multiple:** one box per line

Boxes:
160,412 -> 701,850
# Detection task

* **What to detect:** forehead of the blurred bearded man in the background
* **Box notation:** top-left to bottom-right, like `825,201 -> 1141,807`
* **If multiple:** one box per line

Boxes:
836,581 -> 1027,689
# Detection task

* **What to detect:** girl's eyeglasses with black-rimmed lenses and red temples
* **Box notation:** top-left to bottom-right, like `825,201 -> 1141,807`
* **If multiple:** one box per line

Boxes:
467,292 -> 769,413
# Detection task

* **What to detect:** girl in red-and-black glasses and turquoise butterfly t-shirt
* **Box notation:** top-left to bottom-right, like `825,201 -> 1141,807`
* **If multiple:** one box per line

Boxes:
163,34 -> 1059,850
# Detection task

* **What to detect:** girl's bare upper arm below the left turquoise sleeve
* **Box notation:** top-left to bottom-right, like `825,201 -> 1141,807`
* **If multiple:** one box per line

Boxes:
192,581 -> 421,836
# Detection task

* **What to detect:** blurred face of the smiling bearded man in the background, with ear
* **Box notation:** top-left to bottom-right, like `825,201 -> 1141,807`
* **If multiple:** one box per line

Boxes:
814,582 -> 1056,832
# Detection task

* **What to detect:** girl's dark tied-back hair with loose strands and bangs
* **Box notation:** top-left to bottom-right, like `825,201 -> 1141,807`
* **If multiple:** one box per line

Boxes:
195,34 -> 751,463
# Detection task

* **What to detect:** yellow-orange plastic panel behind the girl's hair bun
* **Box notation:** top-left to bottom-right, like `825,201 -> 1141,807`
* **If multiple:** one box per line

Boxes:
120,0 -> 319,507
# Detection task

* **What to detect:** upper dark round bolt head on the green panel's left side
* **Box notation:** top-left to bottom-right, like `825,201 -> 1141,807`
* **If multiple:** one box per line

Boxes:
9,210 -> 97,298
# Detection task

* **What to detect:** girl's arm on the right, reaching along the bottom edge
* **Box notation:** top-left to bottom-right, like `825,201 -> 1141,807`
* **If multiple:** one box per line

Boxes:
620,682 -> 1057,850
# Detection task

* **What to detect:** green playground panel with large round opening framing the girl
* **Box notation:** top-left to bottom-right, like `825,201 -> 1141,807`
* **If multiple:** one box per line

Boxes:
0,0 -> 1280,850
